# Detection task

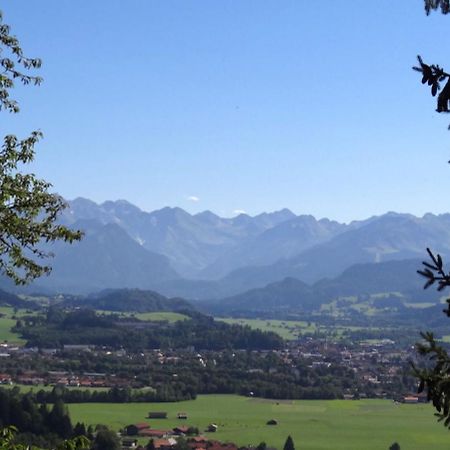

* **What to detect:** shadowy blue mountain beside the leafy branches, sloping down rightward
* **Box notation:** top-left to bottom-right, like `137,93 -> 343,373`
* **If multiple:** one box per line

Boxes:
36,220 -> 179,294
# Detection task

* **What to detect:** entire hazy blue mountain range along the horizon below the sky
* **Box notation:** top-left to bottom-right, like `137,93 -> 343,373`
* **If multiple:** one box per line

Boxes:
6,198 -> 450,299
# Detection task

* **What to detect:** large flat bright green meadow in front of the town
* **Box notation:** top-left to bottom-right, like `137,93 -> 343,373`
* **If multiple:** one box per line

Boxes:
69,395 -> 450,450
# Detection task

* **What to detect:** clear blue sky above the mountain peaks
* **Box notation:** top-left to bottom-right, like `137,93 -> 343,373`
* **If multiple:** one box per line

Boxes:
0,0 -> 450,221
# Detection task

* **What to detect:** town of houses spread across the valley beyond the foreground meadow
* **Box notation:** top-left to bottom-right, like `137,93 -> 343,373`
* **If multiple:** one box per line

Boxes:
0,326 -> 428,398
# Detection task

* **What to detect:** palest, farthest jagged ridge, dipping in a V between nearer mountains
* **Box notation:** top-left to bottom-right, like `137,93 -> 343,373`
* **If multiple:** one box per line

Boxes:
61,198 -> 295,278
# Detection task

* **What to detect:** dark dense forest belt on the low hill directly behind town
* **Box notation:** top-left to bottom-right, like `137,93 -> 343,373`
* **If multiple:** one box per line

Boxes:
15,307 -> 283,351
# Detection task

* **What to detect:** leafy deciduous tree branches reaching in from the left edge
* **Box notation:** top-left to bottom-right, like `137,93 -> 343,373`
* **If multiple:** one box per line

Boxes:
0,12 -> 81,284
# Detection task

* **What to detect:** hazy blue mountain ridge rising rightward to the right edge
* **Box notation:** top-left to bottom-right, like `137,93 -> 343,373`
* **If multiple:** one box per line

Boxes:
219,213 -> 450,283
